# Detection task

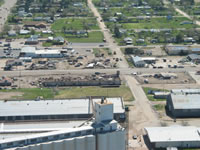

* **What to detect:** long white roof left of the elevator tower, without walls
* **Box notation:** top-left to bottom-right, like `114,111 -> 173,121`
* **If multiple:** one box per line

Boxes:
0,99 -> 91,116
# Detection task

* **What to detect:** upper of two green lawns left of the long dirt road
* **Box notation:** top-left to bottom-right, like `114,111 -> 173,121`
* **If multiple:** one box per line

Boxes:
51,18 -> 99,31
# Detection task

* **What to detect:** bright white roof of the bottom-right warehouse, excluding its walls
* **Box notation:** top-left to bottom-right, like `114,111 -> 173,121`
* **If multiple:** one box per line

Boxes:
145,126 -> 200,142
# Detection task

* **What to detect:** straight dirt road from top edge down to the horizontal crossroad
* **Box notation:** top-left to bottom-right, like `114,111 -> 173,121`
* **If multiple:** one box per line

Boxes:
88,0 -> 128,68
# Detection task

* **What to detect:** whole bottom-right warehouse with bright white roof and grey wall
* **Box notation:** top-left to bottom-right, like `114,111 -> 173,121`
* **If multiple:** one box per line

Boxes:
144,126 -> 200,148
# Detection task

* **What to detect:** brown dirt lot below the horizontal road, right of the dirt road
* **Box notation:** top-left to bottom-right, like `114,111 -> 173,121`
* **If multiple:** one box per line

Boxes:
136,72 -> 196,84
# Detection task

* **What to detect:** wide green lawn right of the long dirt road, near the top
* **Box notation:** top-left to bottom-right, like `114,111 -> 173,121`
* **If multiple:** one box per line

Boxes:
122,17 -> 195,29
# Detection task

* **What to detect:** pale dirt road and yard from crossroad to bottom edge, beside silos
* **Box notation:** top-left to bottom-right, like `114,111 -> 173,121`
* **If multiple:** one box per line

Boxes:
125,76 -> 159,149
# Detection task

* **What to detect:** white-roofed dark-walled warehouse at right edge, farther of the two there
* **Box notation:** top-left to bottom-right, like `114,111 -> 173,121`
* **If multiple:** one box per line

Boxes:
167,89 -> 200,118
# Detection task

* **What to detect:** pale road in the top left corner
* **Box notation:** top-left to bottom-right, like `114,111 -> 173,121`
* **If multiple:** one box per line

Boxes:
0,0 -> 17,32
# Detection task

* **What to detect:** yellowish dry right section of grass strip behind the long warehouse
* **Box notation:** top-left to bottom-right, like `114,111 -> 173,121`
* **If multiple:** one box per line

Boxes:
55,86 -> 134,101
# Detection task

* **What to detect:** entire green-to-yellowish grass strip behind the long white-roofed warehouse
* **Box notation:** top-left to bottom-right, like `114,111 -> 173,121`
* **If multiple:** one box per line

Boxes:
1,85 -> 134,101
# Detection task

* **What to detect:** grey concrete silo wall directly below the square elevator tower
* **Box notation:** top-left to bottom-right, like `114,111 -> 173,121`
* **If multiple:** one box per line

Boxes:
97,130 -> 126,150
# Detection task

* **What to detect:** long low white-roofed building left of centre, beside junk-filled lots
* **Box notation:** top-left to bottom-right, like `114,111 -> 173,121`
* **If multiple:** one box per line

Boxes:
19,47 -> 64,58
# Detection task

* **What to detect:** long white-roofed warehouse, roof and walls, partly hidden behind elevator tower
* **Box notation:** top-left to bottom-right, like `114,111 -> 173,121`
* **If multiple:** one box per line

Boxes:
0,97 -> 125,122
